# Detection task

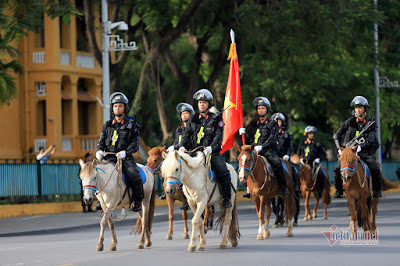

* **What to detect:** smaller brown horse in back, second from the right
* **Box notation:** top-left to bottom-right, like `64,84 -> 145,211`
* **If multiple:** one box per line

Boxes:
291,155 -> 331,221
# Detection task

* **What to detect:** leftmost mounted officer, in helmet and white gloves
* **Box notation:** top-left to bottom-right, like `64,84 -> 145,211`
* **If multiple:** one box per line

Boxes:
96,92 -> 144,212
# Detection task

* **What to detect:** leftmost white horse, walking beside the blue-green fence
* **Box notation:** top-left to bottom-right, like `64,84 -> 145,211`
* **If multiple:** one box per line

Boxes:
79,159 -> 155,251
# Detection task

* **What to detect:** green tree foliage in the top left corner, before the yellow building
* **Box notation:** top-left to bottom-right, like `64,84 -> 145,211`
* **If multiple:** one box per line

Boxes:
0,0 -> 79,105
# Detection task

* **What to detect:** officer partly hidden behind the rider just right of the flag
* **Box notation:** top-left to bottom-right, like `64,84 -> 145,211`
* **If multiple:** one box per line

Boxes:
271,113 -> 300,192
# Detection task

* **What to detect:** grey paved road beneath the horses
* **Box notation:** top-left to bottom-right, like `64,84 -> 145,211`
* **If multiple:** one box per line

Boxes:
0,193 -> 400,266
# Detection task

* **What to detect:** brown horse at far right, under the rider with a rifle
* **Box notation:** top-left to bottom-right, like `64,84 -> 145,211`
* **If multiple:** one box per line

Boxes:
339,146 -> 379,236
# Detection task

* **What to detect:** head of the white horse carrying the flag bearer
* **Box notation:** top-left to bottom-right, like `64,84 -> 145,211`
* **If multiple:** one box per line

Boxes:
161,151 -> 183,196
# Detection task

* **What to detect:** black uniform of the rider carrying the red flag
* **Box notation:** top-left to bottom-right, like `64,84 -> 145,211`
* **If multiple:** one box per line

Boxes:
180,112 -> 231,203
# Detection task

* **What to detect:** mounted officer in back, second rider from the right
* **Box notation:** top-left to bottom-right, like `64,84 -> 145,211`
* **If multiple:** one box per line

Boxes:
297,126 -> 326,197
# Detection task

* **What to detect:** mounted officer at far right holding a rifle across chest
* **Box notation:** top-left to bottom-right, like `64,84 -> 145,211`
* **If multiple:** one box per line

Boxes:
333,96 -> 382,198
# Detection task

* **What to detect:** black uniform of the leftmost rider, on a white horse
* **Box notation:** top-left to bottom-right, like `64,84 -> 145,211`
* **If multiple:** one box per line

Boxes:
98,118 -> 144,207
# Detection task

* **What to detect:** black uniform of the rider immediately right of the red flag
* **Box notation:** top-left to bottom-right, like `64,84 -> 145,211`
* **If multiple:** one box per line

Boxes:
249,119 -> 287,193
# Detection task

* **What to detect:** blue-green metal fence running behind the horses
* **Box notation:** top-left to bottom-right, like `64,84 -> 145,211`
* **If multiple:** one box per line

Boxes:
0,161 -> 400,198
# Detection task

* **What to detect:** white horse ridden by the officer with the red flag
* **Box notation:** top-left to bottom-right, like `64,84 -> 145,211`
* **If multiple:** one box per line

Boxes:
161,151 -> 240,252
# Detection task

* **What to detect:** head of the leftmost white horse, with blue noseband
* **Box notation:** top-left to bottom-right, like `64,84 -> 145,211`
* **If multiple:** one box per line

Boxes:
79,159 -> 98,205
